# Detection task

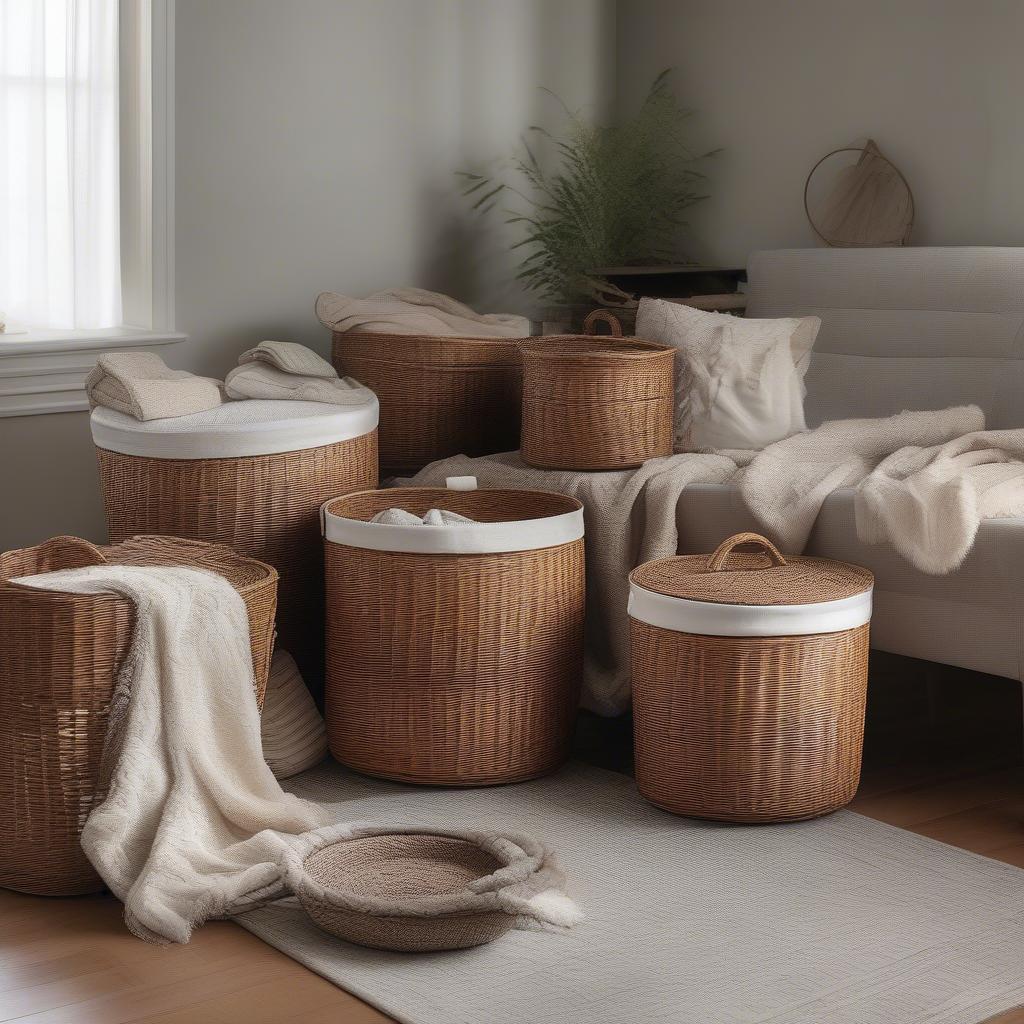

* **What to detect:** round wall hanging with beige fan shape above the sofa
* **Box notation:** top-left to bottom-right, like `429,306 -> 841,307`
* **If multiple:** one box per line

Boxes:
804,139 -> 914,248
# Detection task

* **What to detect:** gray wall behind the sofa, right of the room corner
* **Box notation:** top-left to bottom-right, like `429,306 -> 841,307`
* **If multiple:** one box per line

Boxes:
617,0 -> 1024,265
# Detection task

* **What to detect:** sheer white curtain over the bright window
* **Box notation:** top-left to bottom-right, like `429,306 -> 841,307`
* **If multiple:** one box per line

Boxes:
0,0 -> 121,329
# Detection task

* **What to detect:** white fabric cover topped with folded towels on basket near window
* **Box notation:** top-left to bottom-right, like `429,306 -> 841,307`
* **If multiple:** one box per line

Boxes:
90,389 -> 380,459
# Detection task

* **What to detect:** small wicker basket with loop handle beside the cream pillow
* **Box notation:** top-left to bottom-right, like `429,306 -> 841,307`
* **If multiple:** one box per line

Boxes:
520,309 -> 676,470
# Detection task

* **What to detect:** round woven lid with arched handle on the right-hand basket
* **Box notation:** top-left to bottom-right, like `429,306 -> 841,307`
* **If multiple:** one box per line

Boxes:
630,534 -> 874,606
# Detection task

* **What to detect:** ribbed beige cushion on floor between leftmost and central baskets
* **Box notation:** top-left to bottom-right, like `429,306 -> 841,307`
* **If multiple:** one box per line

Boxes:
260,650 -> 327,778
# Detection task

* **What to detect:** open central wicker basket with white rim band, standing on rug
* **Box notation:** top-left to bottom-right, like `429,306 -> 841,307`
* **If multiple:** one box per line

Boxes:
325,487 -> 584,785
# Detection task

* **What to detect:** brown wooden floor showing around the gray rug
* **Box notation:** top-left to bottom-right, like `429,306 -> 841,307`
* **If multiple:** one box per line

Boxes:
0,675 -> 1024,1024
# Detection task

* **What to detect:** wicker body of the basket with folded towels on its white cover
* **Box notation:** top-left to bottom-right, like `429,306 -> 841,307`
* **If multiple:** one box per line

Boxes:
96,433 -> 377,696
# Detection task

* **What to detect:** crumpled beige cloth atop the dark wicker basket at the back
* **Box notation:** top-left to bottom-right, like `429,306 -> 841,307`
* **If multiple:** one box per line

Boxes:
316,288 -> 529,338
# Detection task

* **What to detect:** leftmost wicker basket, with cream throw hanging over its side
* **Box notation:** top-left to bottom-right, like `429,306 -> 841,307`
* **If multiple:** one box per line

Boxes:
0,537 -> 278,896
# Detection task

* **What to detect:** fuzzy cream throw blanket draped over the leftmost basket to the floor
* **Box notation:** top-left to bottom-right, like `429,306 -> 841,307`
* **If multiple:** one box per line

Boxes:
16,565 -> 581,942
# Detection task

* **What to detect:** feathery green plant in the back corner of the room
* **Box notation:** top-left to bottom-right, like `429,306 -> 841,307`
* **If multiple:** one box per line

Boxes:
461,70 -> 713,321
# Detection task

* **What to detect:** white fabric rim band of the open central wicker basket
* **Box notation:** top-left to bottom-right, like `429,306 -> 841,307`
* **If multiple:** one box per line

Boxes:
321,495 -> 583,555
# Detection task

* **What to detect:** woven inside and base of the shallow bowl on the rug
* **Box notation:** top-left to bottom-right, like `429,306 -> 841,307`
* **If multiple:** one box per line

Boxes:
299,835 -> 515,952
